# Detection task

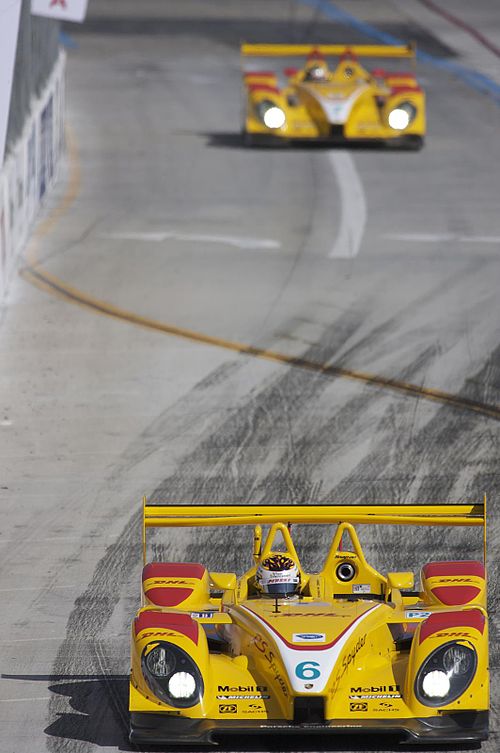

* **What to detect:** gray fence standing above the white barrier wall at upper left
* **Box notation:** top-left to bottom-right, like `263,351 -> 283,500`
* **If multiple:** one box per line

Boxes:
6,0 -> 60,155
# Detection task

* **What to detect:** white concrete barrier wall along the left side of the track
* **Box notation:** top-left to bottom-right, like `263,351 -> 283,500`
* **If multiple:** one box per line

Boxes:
0,51 -> 66,299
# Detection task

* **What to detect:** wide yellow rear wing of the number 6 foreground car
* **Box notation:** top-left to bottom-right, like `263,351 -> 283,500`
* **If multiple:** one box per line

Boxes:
142,495 -> 486,562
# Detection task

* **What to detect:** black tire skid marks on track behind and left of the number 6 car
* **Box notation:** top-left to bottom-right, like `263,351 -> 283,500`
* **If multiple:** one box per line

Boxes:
46,326 -> 500,753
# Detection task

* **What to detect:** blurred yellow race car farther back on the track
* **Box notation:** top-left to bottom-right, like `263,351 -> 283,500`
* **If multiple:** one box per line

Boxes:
241,44 -> 425,149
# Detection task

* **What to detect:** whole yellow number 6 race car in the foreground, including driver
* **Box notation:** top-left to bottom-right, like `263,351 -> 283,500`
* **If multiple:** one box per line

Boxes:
130,503 -> 489,744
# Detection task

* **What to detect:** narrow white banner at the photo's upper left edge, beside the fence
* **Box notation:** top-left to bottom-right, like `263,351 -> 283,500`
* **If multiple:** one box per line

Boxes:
0,0 -> 21,167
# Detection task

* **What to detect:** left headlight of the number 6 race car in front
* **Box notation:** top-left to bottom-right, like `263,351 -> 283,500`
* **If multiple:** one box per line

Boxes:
141,641 -> 203,708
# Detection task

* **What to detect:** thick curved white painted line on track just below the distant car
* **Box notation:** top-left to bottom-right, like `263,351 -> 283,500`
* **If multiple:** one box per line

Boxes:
328,149 -> 366,259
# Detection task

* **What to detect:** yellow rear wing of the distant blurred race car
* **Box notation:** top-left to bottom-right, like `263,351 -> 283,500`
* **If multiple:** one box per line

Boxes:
241,42 -> 417,58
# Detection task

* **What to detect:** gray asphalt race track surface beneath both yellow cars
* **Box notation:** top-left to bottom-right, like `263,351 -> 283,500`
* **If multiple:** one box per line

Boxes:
0,0 -> 500,753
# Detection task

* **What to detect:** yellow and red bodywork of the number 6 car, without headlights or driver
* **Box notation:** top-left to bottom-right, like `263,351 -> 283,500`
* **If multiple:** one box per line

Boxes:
130,502 -> 489,739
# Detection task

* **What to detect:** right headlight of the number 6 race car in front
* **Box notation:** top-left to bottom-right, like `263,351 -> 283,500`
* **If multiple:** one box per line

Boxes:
415,641 -> 477,706
